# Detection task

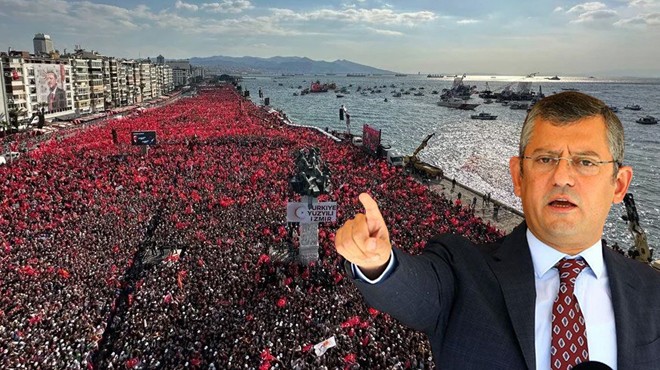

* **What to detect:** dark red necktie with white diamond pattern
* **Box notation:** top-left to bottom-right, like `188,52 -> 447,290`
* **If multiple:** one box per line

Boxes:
550,257 -> 589,370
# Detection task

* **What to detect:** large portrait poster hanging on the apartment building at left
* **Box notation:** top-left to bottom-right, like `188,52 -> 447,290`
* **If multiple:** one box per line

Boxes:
34,64 -> 71,113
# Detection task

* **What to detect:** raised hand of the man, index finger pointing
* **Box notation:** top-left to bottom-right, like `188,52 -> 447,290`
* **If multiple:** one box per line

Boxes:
335,193 -> 392,279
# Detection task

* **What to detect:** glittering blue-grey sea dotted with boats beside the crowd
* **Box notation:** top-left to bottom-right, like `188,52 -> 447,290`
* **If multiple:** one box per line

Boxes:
241,75 -> 660,257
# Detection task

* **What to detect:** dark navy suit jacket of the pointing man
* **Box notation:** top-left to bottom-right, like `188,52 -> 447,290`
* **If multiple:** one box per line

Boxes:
354,223 -> 660,370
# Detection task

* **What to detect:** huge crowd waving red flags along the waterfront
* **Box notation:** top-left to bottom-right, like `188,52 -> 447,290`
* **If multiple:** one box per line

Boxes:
0,86 -> 502,370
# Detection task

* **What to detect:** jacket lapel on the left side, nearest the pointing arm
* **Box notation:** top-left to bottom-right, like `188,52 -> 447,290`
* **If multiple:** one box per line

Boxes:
491,222 -> 536,369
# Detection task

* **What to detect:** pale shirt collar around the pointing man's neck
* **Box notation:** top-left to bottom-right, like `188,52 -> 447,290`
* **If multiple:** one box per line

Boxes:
526,229 -> 605,279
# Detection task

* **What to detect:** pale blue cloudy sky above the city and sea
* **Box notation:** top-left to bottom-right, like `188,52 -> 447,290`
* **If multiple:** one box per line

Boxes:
0,0 -> 660,77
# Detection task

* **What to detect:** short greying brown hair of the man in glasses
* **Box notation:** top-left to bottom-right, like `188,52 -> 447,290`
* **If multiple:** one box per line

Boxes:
518,91 -> 624,168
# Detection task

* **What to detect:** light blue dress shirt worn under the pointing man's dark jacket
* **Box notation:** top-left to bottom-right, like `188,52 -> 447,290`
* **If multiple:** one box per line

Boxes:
527,229 -> 617,370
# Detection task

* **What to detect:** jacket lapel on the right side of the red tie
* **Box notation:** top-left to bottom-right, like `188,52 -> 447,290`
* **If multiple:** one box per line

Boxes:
603,248 -> 642,369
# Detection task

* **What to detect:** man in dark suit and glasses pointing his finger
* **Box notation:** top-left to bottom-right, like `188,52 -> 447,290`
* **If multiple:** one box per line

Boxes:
335,92 -> 660,370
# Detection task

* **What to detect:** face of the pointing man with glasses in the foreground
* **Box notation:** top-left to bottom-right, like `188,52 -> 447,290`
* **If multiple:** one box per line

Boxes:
509,116 -> 632,254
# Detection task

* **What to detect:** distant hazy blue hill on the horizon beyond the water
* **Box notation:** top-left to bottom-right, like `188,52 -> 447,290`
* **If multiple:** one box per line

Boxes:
190,56 -> 394,74
